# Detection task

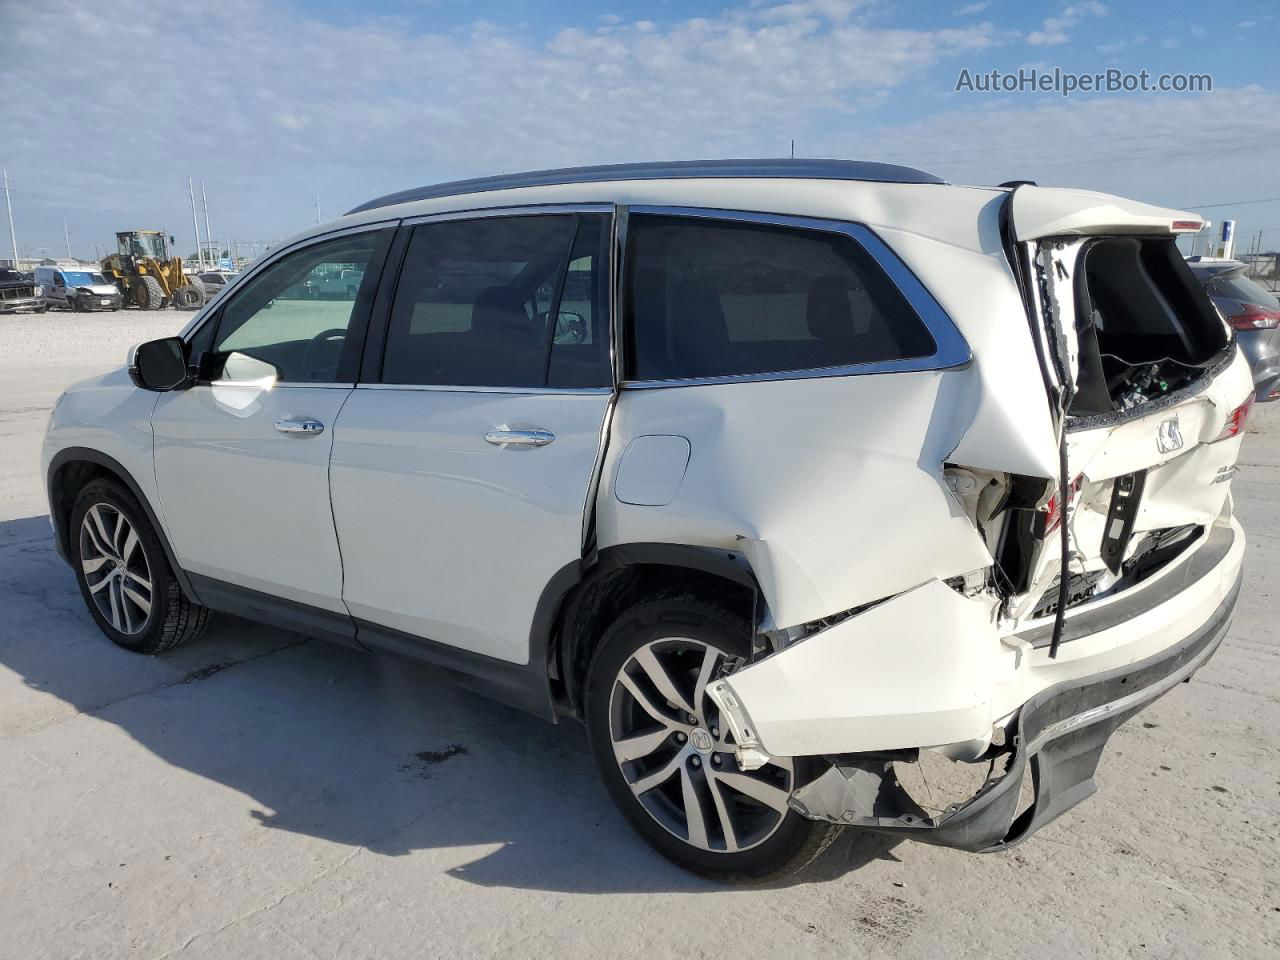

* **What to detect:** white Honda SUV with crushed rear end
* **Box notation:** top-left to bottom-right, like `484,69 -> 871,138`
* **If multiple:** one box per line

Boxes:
44,160 -> 1252,881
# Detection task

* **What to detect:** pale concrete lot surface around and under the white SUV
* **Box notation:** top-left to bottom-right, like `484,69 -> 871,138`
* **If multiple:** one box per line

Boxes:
0,311 -> 1280,960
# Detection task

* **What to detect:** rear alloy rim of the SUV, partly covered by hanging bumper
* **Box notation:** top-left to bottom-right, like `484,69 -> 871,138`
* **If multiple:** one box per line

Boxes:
609,637 -> 795,854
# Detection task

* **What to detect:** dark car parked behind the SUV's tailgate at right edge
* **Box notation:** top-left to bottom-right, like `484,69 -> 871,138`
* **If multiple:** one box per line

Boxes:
1188,257 -> 1280,402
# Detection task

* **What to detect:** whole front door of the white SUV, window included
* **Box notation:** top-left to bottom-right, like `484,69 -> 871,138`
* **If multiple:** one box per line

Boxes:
151,227 -> 394,614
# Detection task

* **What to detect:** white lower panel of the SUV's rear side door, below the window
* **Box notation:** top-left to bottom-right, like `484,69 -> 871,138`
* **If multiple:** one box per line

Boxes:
330,387 -> 609,663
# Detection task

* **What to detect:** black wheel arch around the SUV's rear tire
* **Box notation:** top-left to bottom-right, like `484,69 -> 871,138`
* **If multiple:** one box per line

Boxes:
540,543 -> 760,717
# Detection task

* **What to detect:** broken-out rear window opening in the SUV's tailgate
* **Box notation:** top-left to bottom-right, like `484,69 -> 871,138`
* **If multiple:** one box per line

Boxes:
1070,237 -> 1231,417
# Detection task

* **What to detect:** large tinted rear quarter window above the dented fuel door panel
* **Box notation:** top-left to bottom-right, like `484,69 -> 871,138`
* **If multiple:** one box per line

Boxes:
627,214 -> 936,380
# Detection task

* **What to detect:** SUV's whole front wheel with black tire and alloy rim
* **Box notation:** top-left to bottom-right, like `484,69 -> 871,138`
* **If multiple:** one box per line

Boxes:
68,480 -> 209,654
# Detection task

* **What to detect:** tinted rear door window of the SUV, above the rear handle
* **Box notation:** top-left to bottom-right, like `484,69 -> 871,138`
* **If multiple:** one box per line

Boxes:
381,214 -> 608,388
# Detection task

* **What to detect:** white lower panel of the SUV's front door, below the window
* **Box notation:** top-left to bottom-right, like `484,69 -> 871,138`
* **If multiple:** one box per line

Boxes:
152,384 -> 351,613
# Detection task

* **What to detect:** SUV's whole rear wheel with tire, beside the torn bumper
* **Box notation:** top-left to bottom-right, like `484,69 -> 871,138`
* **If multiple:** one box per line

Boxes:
586,596 -> 840,883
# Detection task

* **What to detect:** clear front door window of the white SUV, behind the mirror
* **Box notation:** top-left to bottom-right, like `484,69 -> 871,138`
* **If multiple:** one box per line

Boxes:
206,230 -> 389,383
